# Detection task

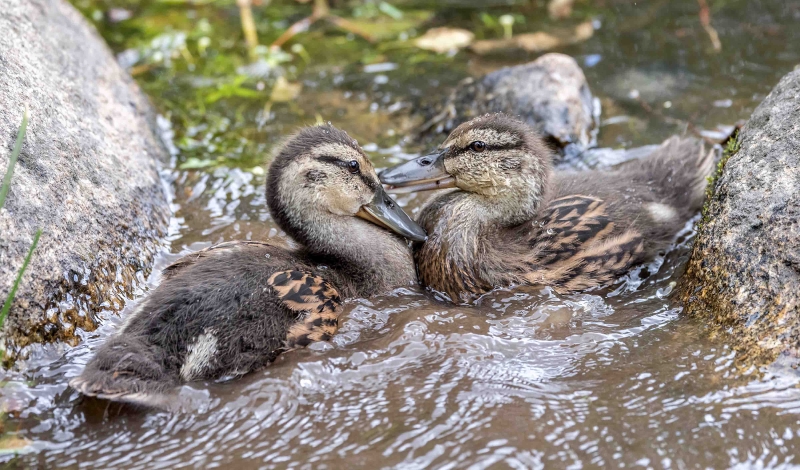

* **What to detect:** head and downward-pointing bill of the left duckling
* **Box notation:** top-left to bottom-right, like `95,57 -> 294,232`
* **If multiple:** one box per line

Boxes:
267,125 -> 426,253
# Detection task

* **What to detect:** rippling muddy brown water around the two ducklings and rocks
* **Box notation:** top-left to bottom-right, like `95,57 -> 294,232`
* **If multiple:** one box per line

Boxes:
0,1 -> 800,469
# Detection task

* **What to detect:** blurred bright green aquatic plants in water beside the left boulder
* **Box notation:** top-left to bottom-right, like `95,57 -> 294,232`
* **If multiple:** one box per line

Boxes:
71,0 -> 462,171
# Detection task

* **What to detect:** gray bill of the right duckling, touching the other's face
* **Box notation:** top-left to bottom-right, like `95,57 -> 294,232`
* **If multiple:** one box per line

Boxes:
378,149 -> 456,191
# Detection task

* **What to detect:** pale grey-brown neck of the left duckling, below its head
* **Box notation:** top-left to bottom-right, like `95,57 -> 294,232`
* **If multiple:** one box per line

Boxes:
290,217 -> 417,297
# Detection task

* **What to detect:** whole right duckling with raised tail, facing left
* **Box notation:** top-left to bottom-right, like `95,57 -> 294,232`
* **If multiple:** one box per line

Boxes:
379,114 -> 714,302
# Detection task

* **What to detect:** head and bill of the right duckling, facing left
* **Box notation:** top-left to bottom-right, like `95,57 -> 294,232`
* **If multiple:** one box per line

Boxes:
380,113 -> 552,223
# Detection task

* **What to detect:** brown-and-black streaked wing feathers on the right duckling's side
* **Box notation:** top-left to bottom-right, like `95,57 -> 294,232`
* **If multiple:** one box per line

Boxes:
524,195 -> 643,292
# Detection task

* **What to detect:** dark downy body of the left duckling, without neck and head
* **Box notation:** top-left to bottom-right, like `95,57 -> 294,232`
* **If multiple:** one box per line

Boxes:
70,242 -> 341,406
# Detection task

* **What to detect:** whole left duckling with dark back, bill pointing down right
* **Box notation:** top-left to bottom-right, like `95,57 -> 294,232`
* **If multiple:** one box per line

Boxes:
70,125 -> 425,406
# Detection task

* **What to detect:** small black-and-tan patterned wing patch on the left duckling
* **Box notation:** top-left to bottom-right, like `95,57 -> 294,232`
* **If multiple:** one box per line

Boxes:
268,270 -> 342,348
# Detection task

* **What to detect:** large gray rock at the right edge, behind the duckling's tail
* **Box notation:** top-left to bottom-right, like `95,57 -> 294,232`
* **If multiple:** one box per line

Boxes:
682,70 -> 800,364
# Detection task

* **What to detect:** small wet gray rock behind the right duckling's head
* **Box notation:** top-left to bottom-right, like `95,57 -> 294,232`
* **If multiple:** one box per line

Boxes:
418,54 -> 595,154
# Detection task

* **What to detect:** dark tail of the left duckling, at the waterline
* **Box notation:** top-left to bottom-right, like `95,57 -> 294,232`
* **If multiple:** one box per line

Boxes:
69,337 -> 178,406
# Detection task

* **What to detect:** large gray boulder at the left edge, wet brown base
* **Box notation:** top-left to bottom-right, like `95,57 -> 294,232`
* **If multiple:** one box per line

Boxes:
0,0 -> 169,353
